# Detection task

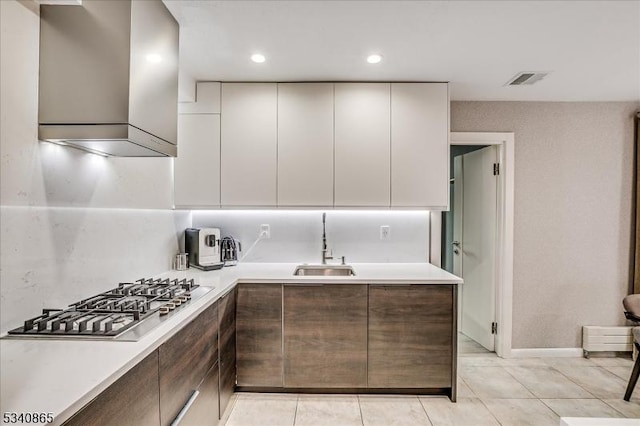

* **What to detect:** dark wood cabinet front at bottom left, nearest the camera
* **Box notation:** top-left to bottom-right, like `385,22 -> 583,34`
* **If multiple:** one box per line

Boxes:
64,352 -> 160,426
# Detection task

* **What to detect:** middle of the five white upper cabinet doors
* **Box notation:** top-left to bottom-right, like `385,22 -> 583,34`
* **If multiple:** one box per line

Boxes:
278,83 -> 333,206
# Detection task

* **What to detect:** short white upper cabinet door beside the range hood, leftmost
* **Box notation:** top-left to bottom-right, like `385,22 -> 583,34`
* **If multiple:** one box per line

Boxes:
174,114 -> 220,207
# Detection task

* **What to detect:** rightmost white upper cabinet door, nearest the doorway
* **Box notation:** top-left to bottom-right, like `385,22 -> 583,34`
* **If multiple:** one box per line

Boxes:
391,83 -> 449,210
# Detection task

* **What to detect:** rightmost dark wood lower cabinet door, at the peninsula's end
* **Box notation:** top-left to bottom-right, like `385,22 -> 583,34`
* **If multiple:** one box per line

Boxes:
368,285 -> 456,388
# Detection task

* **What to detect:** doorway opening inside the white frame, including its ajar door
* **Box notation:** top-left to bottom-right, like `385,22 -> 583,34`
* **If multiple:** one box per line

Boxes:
442,145 -> 500,353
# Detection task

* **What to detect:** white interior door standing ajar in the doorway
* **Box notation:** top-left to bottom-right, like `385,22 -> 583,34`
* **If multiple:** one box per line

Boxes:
454,146 -> 498,351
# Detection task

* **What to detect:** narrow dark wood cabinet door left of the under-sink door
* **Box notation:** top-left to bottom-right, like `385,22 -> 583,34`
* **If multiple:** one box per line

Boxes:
236,284 -> 282,387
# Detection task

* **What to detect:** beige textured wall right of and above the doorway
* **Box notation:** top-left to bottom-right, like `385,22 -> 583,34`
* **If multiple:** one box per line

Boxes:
451,102 -> 640,348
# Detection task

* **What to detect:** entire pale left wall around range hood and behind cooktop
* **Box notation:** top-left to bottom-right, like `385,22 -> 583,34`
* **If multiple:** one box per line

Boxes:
0,0 -> 191,333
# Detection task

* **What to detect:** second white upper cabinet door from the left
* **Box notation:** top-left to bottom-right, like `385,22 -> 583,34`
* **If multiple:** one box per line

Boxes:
221,83 -> 278,207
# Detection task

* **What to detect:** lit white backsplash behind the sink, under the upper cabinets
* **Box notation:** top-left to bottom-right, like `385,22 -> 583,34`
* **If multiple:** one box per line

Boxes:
192,210 -> 429,263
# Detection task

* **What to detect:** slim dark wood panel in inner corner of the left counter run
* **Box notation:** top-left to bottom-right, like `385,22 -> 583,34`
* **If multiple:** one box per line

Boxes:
218,288 -> 236,415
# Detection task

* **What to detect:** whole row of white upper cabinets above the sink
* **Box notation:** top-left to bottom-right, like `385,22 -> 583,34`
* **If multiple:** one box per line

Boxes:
174,82 -> 449,210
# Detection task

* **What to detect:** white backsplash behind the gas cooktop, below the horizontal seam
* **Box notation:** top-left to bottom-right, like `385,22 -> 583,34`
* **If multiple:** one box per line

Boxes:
0,206 -> 191,333
